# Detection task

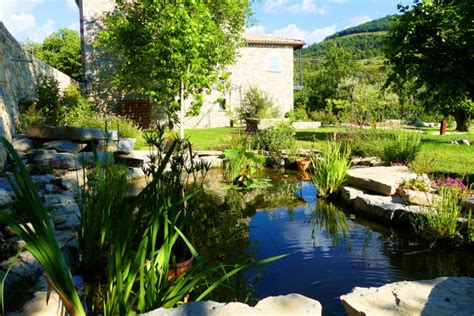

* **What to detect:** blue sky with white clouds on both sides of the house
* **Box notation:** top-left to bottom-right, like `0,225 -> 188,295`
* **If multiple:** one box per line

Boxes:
0,0 -> 412,43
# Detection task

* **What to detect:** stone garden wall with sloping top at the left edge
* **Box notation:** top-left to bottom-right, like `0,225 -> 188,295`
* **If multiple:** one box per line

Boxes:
0,22 -> 75,167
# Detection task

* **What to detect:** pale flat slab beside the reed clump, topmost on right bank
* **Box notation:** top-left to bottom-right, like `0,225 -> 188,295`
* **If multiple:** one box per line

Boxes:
348,166 -> 416,195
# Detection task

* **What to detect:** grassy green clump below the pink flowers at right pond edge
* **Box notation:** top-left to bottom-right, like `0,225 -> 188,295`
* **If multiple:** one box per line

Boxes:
411,187 -> 463,238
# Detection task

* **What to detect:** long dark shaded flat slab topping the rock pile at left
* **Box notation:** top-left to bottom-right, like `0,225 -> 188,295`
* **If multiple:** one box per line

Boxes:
25,125 -> 118,142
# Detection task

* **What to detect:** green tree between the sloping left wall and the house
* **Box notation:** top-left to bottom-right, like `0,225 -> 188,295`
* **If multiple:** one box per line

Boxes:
24,28 -> 82,80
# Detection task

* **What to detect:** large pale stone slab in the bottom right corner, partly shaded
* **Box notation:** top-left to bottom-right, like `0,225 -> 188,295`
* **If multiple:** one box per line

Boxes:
340,277 -> 474,316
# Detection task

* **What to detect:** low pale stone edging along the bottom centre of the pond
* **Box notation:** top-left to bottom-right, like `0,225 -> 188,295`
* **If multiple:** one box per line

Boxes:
142,294 -> 322,316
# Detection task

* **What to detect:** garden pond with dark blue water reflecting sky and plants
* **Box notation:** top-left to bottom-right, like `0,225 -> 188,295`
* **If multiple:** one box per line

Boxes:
193,171 -> 474,315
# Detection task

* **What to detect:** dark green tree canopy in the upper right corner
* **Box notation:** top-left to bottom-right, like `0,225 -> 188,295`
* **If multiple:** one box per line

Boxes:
386,0 -> 474,131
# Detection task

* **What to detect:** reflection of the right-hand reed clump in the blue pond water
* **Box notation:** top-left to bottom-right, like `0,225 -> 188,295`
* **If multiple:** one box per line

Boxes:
309,199 -> 350,247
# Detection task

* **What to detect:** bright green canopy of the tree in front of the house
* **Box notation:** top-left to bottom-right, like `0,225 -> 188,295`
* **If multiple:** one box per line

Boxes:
99,0 -> 250,124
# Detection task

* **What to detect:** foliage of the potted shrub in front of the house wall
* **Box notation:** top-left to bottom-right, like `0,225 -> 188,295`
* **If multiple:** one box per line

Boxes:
237,87 -> 279,119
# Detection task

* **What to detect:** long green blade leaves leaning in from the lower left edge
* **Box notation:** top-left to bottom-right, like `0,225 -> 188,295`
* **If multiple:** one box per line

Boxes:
0,137 -> 85,316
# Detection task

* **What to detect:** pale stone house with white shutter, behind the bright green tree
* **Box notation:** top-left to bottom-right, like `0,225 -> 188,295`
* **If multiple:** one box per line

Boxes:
76,0 -> 305,128
